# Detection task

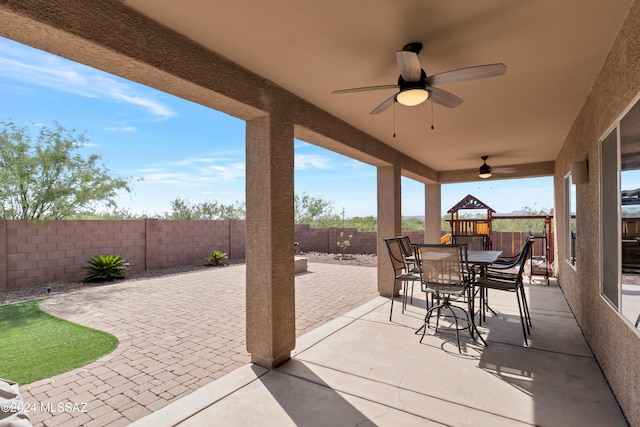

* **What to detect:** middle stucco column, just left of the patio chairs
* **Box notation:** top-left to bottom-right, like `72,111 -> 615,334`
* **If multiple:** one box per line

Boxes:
378,166 -> 402,296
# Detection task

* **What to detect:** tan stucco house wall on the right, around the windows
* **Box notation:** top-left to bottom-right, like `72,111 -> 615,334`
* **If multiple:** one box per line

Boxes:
555,1 -> 640,425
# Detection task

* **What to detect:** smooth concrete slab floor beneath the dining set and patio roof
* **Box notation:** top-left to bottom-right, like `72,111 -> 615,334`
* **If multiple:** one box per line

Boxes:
134,280 -> 627,427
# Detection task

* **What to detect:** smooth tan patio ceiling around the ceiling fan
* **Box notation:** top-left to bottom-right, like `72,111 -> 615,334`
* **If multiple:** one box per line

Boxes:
125,0 -> 631,176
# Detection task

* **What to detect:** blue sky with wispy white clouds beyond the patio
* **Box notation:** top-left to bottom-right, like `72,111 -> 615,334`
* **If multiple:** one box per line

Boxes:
0,38 -> 553,217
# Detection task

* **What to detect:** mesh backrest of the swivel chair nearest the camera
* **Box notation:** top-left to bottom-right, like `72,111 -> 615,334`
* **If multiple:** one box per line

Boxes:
413,244 -> 469,289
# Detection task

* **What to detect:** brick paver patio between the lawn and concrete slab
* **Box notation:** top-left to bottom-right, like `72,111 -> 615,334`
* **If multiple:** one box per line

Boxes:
20,263 -> 377,427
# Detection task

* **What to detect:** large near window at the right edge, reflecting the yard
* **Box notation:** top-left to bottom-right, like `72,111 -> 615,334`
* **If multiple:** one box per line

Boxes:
600,93 -> 640,328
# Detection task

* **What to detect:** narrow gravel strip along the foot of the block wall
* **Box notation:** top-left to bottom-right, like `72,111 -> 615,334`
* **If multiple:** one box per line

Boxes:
0,252 -> 378,305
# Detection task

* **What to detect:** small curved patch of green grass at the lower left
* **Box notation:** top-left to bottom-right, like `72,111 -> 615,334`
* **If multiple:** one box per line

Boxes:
0,300 -> 118,384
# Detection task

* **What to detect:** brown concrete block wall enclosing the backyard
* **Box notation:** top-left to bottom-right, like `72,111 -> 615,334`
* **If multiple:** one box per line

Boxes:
0,219 -> 544,290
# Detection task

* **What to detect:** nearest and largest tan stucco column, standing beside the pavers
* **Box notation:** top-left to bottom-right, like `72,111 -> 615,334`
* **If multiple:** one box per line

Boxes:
246,113 -> 296,368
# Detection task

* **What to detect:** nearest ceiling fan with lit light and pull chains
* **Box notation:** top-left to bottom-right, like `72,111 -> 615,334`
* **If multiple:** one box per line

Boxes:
331,42 -> 507,114
